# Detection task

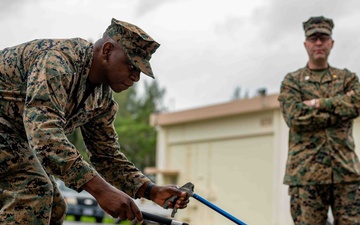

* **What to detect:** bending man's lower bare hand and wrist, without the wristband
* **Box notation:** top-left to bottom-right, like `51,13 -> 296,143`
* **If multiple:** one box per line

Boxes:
82,176 -> 143,223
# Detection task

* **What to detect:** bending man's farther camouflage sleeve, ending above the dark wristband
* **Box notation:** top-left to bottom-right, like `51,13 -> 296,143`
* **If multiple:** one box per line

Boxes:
81,100 -> 150,198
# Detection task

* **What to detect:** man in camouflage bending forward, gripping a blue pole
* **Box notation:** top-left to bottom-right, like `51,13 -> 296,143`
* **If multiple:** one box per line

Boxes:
0,19 -> 189,225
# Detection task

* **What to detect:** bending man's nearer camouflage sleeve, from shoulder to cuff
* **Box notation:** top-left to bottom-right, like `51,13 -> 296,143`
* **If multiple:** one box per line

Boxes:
23,51 -> 97,191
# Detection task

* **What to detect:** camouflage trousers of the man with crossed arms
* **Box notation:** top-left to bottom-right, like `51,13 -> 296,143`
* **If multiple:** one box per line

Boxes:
289,183 -> 360,225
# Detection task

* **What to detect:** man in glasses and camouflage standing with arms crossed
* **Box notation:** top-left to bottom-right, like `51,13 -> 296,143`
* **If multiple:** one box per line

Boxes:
279,16 -> 360,225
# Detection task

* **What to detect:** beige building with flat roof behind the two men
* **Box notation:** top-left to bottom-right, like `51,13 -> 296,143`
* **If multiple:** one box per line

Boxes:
147,95 -> 360,225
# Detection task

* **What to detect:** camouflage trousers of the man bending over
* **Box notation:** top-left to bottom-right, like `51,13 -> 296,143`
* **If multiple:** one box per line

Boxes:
0,117 -> 66,225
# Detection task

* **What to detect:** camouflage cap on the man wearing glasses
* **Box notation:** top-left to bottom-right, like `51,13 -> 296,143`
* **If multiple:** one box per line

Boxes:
303,16 -> 334,37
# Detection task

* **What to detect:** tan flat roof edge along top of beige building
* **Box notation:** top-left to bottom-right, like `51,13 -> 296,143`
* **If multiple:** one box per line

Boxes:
150,94 -> 280,126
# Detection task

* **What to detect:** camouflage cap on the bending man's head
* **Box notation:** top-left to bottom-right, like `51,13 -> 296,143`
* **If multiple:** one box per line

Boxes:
105,18 -> 160,78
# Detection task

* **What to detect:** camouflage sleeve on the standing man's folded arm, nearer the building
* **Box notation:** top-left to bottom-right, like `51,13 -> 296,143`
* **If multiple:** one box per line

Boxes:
278,74 -> 341,131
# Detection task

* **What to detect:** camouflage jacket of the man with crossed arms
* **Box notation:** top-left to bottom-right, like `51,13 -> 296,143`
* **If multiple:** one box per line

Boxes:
278,67 -> 360,185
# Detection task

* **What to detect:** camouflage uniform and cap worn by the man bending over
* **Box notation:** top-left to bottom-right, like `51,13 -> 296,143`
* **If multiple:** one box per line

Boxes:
0,19 -> 158,225
